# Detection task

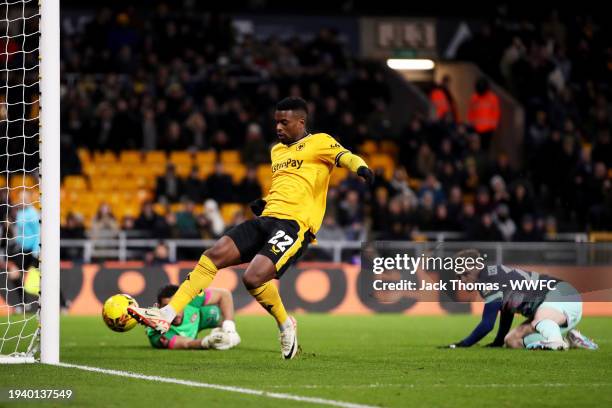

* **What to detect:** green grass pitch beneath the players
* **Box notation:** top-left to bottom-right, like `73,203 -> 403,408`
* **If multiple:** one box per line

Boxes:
0,315 -> 612,408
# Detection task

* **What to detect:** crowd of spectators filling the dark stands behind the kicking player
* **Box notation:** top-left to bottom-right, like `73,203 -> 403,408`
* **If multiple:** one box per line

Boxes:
53,3 -> 612,252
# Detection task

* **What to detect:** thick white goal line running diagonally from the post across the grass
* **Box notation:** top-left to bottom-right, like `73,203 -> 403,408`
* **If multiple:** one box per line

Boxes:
55,363 -> 377,408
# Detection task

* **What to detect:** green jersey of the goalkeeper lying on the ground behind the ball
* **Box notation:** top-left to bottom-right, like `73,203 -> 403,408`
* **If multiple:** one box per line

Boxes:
147,291 -> 221,349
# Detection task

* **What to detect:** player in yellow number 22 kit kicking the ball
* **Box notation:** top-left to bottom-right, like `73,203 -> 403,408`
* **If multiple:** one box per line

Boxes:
128,98 -> 374,359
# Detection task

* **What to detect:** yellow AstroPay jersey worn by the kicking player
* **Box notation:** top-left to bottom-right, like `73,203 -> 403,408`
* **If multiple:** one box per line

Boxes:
261,133 -> 348,234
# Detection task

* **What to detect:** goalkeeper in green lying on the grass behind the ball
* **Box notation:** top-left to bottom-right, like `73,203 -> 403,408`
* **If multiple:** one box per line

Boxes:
147,285 -> 240,350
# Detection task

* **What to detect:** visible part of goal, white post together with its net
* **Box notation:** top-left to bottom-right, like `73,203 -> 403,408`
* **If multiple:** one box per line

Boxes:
0,0 -> 60,364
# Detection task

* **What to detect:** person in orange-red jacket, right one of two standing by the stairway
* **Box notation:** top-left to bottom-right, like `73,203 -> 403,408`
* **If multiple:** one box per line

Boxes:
468,78 -> 500,152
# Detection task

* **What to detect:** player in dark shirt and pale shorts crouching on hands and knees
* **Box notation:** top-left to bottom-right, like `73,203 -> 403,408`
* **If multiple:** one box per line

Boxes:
449,250 -> 598,350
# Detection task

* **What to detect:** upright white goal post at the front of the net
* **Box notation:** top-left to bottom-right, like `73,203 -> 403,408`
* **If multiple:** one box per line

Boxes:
39,0 -> 60,364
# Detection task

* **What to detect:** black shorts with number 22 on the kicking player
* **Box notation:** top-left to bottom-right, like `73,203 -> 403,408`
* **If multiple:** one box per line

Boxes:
225,217 -> 314,278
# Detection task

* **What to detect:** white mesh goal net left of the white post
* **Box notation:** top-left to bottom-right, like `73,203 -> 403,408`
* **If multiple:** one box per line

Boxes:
0,0 -> 59,363
